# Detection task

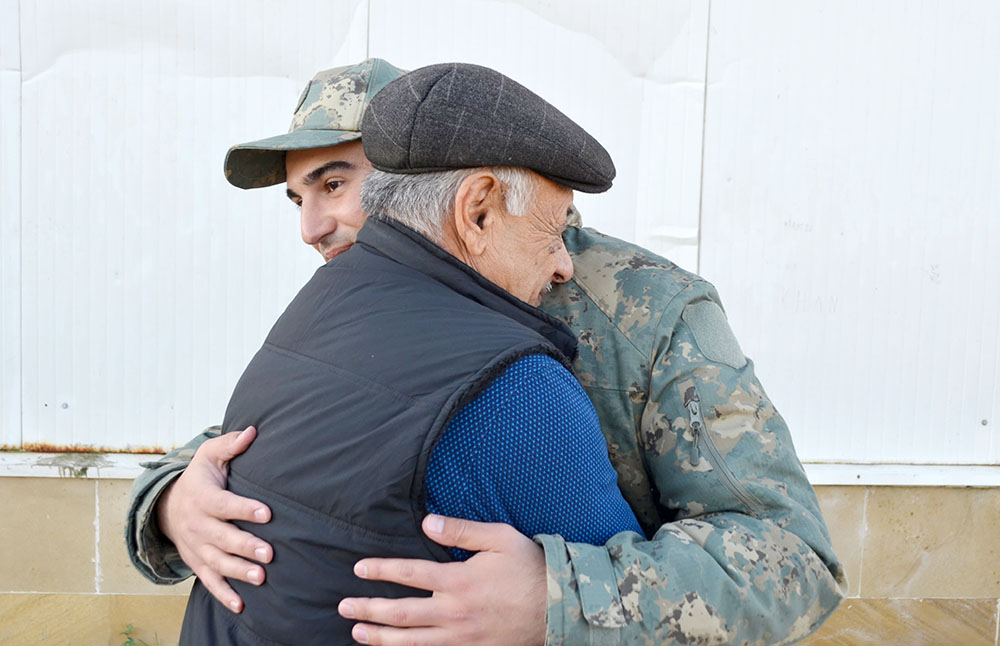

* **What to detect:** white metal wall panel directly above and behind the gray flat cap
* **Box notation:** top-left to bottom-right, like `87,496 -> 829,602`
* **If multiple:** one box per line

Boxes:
370,0 -> 708,269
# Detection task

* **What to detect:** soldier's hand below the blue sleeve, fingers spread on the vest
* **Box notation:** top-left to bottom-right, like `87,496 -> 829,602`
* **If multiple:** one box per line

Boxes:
337,516 -> 546,646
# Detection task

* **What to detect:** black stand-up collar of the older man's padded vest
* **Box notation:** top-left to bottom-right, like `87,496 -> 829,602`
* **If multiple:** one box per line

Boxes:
357,217 -> 577,362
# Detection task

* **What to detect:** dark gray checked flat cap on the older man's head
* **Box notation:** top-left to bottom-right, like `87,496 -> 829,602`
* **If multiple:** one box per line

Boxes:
361,63 -> 615,193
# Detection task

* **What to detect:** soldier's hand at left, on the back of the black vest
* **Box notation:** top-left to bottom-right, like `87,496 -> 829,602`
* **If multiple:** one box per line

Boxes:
156,426 -> 273,612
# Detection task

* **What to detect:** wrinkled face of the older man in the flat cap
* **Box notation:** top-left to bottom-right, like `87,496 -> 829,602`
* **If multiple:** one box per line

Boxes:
476,175 -> 573,307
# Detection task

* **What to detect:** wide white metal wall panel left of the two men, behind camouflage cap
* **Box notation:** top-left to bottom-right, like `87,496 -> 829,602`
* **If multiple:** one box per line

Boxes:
21,0 -> 368,449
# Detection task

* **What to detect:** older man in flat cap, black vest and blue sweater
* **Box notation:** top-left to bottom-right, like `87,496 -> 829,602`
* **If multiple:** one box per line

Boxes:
181,64 -> 642,645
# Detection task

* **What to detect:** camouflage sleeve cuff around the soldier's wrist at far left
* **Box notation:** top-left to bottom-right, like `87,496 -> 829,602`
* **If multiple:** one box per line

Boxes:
125,426 -> 221,584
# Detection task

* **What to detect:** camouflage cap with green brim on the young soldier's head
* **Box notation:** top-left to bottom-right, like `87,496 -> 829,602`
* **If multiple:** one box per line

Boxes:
224,58 -> 406,188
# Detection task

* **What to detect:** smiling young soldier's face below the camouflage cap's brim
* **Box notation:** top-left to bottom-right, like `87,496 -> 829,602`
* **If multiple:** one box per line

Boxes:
285,141 -> 372,260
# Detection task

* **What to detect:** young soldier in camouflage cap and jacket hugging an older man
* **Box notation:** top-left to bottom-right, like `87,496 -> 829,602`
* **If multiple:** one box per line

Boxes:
126,62 -> 846,644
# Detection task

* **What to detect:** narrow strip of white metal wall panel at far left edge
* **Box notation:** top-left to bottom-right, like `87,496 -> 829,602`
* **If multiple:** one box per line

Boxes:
0,0 -> 21,447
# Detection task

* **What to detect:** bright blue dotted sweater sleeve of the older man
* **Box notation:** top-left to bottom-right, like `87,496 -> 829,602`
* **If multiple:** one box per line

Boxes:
426,355 -> 641,558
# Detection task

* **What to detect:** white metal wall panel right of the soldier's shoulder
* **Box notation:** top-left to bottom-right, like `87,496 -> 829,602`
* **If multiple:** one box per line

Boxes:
701,0 -> 1000,464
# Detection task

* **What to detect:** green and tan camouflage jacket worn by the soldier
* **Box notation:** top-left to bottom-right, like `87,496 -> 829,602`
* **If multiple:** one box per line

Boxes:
126,227 -> 846,645
